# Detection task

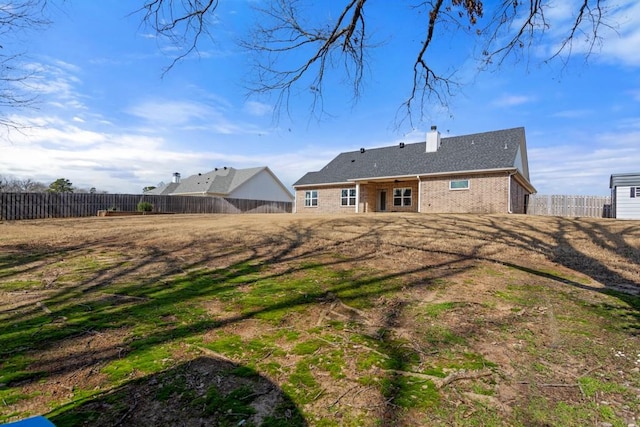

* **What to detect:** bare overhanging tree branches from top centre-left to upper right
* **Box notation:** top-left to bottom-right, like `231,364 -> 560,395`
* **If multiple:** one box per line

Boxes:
141,0 -> 607,123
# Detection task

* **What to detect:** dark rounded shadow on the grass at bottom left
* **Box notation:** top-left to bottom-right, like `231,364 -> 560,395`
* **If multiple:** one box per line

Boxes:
47,357 -> 308,427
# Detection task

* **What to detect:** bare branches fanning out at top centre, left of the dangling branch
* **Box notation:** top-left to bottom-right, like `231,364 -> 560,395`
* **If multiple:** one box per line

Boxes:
242,0 -> 367,119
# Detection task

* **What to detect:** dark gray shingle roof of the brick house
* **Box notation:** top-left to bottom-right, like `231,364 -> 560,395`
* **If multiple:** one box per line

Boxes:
293,127 -> 529,187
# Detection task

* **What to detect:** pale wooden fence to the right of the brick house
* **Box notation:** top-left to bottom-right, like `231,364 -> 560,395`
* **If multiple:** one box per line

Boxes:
527,194 -> 611,218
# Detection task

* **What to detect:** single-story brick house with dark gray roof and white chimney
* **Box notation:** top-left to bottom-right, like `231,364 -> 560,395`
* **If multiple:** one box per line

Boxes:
293,126 -> 536,213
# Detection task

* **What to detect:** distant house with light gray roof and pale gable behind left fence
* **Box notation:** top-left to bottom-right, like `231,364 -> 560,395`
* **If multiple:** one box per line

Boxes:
144,166 -> 293,202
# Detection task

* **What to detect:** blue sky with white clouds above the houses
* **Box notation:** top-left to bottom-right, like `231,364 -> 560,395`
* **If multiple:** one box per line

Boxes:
0,0 -> 640,195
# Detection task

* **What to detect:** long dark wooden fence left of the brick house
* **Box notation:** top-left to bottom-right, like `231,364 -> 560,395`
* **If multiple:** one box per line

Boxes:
0,193 -> 292,220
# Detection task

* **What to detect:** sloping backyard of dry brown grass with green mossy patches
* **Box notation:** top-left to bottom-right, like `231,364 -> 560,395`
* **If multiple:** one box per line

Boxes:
0,214 -> 640,426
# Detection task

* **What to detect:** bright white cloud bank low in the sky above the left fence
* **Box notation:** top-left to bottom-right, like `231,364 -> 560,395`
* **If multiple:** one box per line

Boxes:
0,105 -> 316,193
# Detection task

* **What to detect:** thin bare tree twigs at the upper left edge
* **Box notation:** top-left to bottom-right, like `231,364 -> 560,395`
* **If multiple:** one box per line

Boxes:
0,0 -> 49,128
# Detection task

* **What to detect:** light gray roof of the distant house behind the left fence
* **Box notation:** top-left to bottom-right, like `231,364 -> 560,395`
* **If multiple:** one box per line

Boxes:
146,166 -> 267,196
